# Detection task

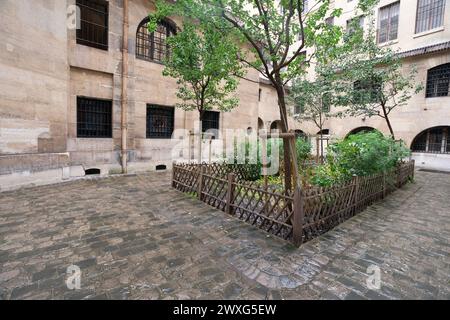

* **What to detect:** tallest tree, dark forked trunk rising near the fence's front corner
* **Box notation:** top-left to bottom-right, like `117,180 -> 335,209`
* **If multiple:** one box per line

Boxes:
152,0 -> 350,190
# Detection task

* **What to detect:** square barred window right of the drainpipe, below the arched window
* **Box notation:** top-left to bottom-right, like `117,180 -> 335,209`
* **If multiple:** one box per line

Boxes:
147,105 -> 175,139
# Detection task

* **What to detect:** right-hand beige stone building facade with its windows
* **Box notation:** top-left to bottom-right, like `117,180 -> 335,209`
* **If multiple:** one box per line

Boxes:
300,0 -> 450,171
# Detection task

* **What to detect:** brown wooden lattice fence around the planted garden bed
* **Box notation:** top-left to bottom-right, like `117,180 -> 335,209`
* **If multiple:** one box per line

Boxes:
172,161 -> 414,246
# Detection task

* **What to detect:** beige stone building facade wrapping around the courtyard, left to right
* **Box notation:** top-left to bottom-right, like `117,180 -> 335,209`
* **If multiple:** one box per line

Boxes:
0,0 -> 450,190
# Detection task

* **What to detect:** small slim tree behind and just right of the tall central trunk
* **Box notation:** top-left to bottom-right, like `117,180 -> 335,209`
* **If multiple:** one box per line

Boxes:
289,76 -> 342,162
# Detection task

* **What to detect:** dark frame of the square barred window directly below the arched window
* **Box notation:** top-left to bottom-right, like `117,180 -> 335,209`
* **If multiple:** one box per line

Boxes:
145,103 -> 175,139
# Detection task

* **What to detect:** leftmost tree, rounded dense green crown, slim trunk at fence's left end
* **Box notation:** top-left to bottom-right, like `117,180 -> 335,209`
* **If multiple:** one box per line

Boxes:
158,23 -> 243,162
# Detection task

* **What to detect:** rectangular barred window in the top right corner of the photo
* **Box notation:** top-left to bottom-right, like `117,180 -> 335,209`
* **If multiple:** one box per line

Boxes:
416,0 -> 445,33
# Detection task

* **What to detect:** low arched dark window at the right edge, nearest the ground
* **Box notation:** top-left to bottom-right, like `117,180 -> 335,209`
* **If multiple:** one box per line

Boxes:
411,127 -> 450,153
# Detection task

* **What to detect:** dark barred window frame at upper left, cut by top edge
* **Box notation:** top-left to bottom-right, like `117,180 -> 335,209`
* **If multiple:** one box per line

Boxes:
76,0 -> 109,51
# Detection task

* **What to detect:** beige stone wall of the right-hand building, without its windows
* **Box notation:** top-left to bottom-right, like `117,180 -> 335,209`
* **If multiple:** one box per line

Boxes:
301,0 -> 450,146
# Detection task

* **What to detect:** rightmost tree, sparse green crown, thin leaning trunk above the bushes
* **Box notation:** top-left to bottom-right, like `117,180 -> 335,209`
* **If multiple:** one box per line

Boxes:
330,11 -> 423,139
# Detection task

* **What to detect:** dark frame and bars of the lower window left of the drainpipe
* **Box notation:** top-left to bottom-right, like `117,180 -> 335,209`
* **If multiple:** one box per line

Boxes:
76,96 -> 113,139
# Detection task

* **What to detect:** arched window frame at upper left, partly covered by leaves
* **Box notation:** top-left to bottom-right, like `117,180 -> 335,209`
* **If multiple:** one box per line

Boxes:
135,17 -> 177,64
